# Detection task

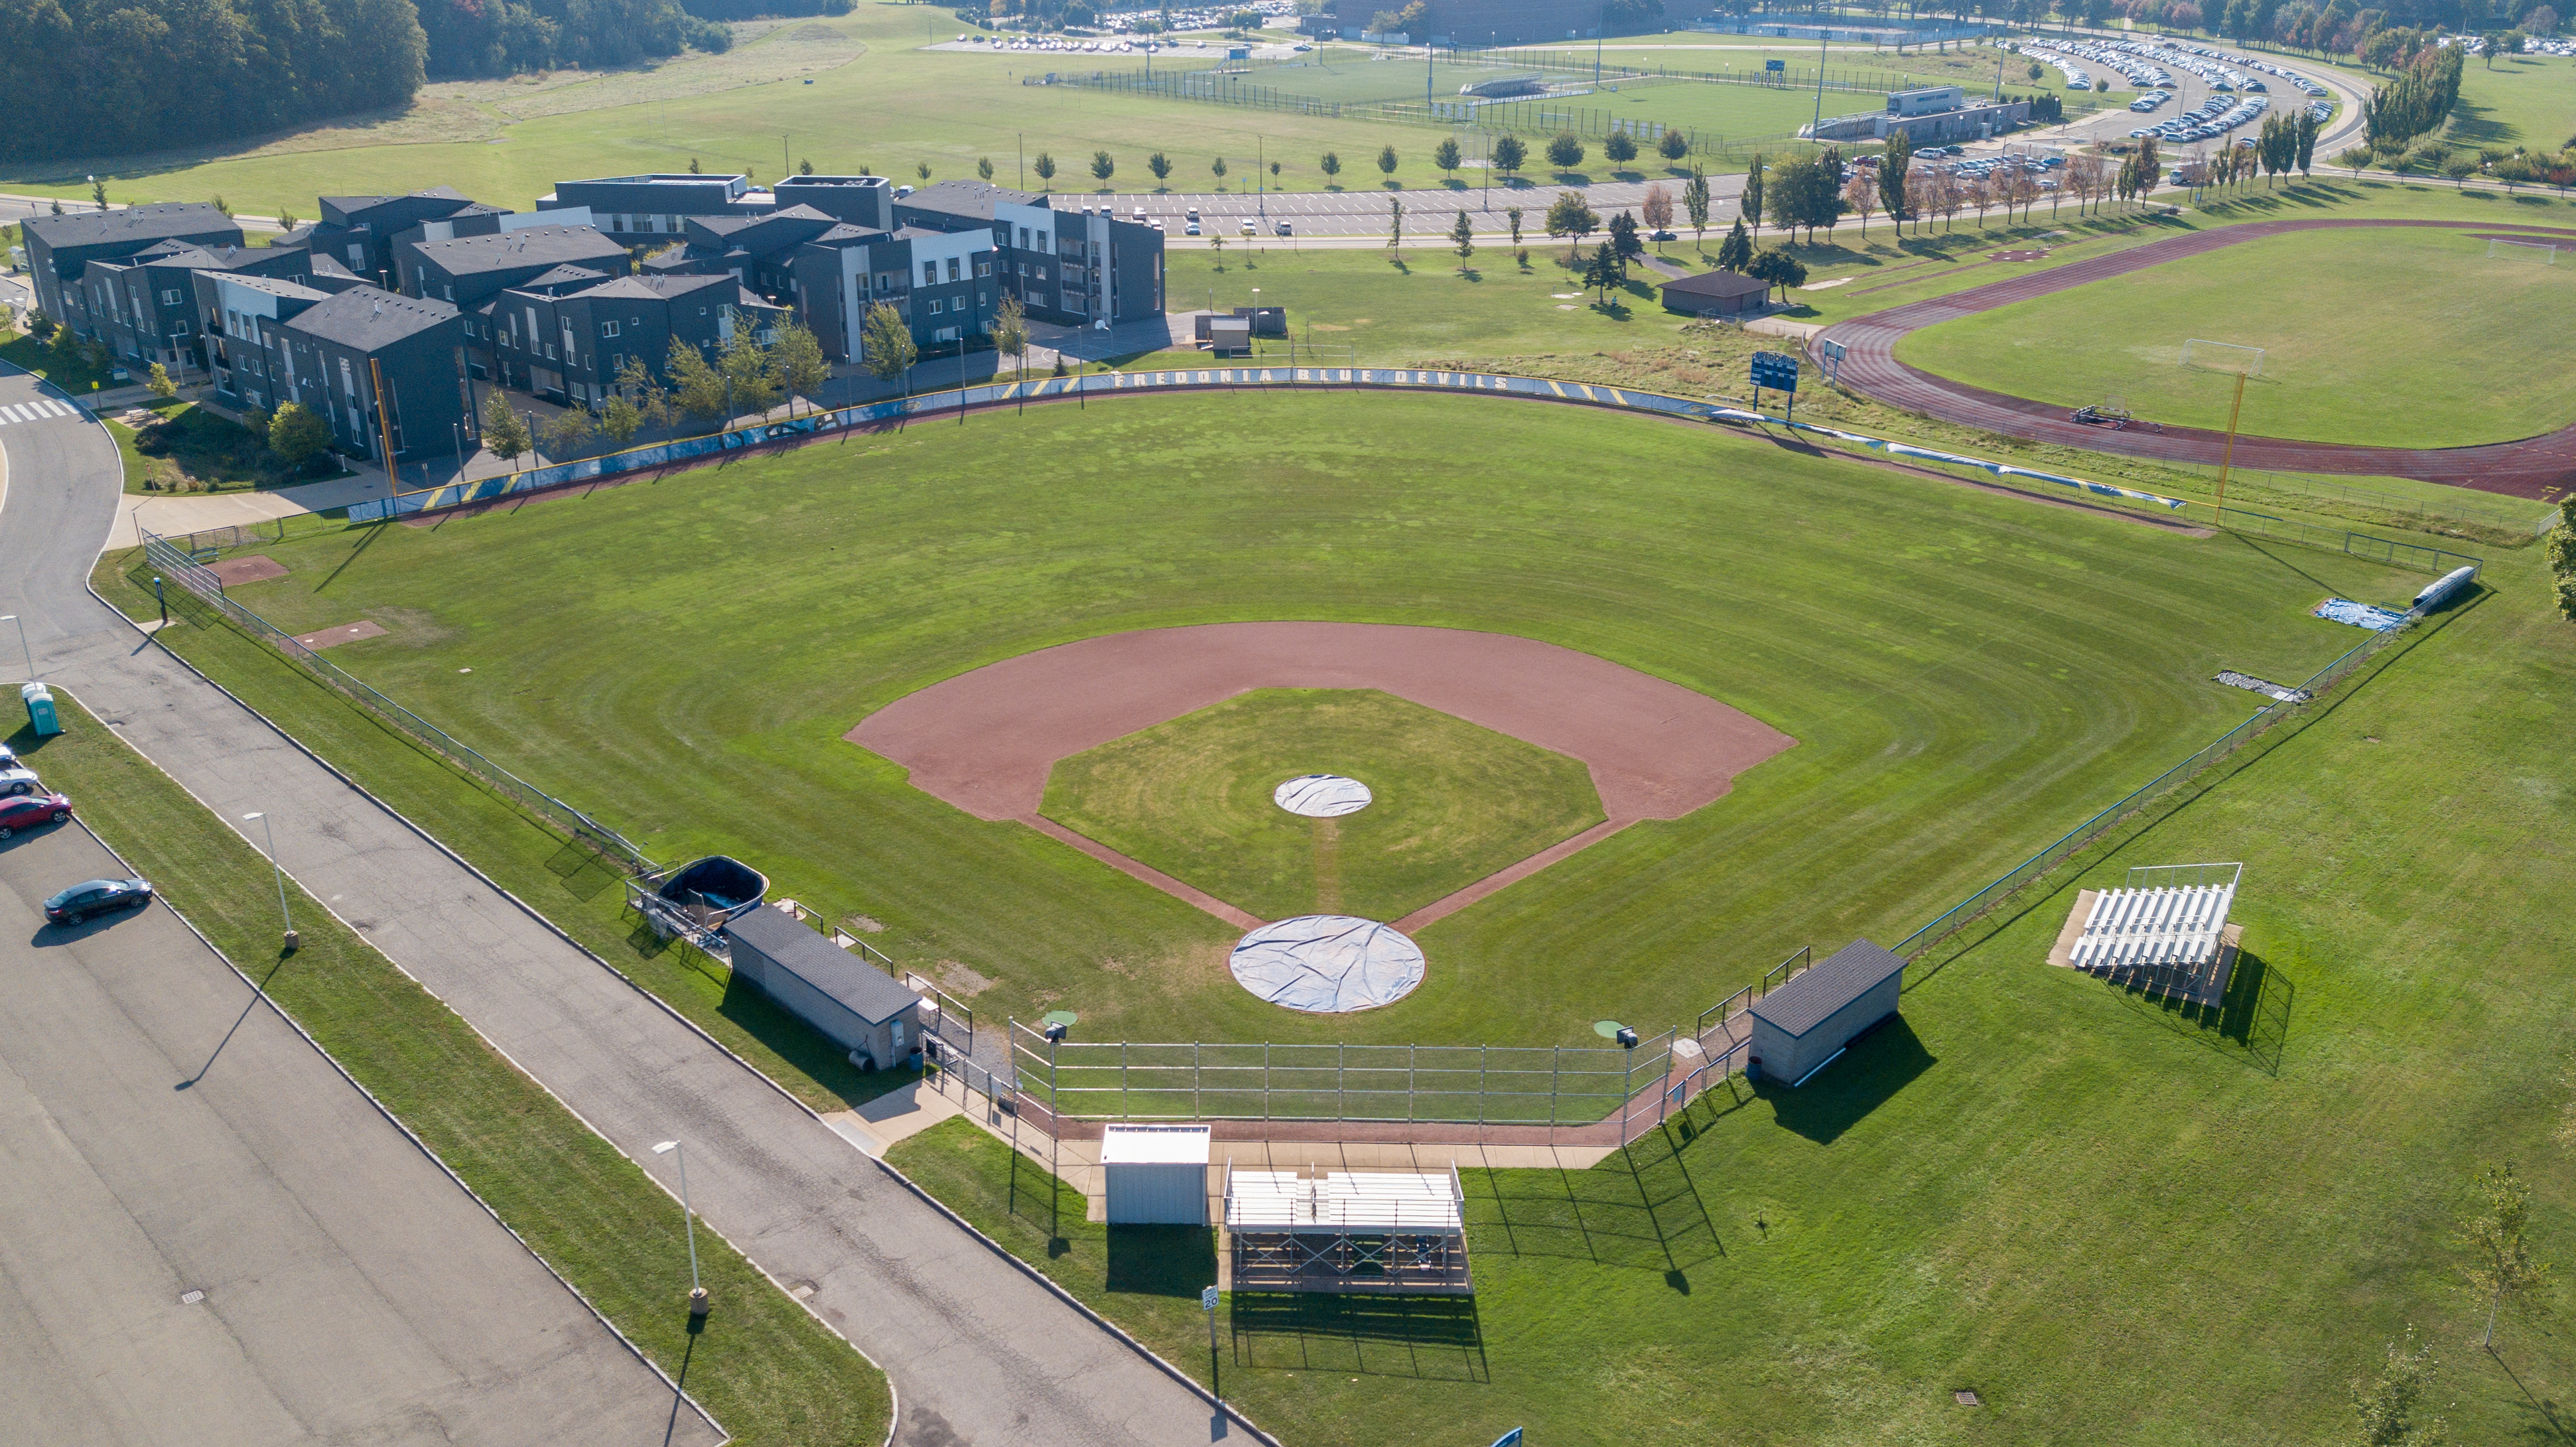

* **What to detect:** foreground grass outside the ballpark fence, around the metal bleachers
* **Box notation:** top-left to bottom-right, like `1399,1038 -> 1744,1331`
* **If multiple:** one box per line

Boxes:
889,522 -> 2576,1447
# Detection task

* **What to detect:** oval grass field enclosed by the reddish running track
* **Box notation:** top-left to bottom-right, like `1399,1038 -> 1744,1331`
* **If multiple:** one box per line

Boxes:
1896,216 -> 2576,448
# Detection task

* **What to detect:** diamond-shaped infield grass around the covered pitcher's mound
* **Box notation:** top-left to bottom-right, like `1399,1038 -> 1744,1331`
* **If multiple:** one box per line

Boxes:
1046,687 -> 1602,919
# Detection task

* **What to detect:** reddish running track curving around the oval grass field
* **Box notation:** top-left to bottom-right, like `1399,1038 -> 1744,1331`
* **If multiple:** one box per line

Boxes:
1808,216 -> 2576,500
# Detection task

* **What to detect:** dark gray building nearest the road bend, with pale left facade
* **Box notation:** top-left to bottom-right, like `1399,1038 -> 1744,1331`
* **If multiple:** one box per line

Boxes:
193,270 -> 474,464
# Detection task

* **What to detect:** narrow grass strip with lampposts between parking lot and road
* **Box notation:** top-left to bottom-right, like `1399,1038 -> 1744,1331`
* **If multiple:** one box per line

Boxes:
8,690 -> 894,1447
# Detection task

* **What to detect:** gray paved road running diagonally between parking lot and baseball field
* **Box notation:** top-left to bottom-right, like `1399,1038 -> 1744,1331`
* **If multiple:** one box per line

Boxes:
0,376 -> 1244,1447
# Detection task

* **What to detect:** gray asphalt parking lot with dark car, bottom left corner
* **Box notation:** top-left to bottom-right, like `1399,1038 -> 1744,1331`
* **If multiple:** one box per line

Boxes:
0,803 -> 721,1447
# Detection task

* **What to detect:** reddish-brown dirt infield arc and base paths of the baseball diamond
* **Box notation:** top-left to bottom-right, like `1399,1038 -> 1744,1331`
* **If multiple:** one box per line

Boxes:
845,623 -> 1798,932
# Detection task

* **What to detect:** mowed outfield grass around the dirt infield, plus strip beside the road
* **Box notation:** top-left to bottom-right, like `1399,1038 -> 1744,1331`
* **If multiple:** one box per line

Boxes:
100,394 -> 2419,1076
